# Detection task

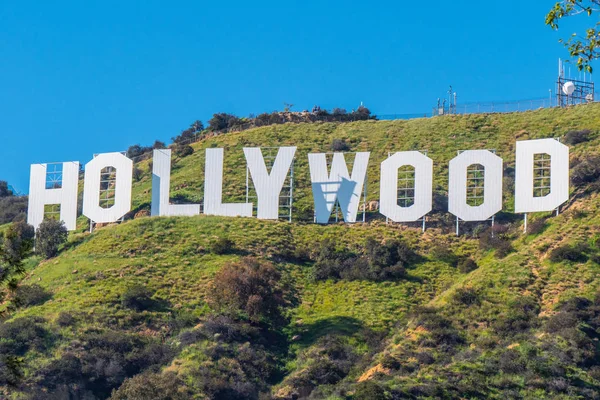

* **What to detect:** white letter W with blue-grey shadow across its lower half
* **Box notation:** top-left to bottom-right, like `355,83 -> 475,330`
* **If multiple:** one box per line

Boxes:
308,152 -> 371,224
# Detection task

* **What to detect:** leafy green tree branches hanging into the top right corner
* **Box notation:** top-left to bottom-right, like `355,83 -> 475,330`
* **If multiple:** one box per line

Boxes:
546,0 -> 600,73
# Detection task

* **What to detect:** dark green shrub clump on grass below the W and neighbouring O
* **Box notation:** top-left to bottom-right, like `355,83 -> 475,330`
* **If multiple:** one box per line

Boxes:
313,238 -> 418,281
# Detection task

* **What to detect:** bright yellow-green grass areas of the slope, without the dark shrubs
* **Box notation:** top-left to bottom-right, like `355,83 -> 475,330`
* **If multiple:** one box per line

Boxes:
3,104 -> 600,396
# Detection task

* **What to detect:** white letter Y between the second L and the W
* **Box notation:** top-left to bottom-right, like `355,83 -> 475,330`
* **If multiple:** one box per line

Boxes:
244,147 -> 296,219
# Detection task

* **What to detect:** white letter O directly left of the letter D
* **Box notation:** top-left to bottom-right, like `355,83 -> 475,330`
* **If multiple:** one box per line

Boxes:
448,150 -> 502,221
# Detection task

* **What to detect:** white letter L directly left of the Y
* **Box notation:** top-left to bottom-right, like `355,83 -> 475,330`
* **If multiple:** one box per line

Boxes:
204,149 -> 252,217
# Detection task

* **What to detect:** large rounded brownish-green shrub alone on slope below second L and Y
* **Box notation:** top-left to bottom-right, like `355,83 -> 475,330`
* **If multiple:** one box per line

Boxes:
209,257 -> 289,323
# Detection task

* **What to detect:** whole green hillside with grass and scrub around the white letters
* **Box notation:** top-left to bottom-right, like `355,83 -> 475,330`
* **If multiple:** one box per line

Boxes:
0,104 -> 600,400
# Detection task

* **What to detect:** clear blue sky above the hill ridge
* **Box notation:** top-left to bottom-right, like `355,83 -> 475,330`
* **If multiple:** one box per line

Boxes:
0,0 -> 589,191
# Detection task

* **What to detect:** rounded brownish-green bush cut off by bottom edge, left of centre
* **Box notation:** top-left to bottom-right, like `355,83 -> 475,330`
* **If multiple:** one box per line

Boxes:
110,372 -> 191,400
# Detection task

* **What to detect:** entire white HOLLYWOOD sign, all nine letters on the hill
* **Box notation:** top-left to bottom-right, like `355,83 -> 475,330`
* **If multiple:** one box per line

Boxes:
28,139 -> 569,230
